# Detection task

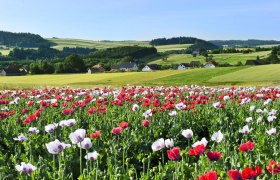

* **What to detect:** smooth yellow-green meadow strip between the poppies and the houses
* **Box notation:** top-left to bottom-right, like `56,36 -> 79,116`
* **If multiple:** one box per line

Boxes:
0,65 -> 280,89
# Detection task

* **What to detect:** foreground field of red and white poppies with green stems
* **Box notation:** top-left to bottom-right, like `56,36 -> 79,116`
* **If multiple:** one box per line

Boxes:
0,86 -> 280,180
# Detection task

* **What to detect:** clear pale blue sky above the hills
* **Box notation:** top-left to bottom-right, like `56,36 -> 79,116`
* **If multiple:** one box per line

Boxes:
0,0 -> 280,40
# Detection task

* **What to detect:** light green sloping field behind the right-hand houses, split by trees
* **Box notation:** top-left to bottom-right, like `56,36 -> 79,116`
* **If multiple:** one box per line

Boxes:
149,51 -> 270,65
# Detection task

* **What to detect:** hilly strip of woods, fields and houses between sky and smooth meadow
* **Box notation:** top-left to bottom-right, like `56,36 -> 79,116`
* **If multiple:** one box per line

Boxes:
0,31 -> 280,76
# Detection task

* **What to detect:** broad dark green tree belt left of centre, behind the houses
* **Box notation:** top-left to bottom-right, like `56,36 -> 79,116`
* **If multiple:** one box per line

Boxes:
0,46 -> 157,74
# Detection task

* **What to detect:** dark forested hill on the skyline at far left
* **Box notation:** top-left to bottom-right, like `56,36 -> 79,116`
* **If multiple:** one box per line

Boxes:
0,31 -> 51,48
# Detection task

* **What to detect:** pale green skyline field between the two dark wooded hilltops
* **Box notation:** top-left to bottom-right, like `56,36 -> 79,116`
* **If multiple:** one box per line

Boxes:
48,38 -> 150,50
